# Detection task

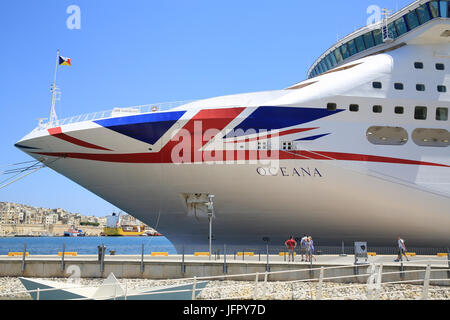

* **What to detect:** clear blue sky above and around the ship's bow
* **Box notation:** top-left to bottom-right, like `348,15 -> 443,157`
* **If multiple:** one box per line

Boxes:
0,0 -> 411,216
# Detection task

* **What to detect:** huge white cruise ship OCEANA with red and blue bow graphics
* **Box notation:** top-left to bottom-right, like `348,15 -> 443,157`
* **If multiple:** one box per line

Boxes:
16,0 -> 450,248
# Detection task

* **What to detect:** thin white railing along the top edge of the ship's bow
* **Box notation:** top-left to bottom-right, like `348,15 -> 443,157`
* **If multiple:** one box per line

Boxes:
34,100 -> 195,131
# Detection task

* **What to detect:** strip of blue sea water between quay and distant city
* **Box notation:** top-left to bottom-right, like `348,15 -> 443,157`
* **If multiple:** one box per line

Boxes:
0,236 -> 176,255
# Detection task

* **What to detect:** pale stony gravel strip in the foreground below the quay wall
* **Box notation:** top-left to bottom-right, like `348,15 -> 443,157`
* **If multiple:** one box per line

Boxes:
0,278 -> 450,300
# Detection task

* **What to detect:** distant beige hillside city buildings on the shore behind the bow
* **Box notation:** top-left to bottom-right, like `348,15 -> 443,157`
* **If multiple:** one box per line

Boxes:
0,202 -> 154,237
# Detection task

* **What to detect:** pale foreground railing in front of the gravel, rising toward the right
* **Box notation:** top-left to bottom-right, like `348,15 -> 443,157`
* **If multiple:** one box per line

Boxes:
4,260 -> 450,300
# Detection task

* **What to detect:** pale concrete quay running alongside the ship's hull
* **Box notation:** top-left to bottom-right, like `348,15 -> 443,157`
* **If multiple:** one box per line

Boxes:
0,255 -> 450,286
